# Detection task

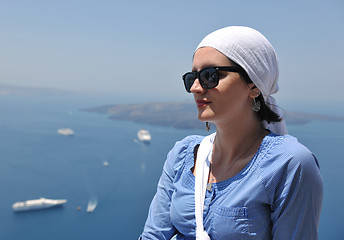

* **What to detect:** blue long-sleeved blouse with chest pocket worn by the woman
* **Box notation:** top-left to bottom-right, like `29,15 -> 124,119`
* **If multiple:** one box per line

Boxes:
142,133 -> 323,240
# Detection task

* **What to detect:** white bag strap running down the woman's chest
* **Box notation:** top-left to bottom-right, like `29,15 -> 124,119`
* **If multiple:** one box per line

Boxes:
195,133 -> 216,240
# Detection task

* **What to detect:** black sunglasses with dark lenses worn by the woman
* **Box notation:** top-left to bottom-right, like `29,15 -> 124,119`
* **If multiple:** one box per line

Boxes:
182,66 -> 245,93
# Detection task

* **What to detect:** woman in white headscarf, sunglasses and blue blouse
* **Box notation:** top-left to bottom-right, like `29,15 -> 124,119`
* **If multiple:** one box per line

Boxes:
141,27 -> 322,240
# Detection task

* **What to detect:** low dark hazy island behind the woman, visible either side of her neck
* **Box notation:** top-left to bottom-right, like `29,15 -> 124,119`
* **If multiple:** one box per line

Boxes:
81,102 -> 344,129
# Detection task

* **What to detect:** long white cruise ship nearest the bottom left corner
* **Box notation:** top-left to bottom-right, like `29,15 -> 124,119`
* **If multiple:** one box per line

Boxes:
12,198 -> 67,212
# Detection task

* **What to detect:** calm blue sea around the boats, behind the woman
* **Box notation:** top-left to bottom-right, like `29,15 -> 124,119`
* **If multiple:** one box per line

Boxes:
0,96 -> 344,240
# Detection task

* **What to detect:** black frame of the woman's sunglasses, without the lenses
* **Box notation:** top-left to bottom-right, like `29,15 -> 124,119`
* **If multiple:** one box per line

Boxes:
182,66 -> 245,93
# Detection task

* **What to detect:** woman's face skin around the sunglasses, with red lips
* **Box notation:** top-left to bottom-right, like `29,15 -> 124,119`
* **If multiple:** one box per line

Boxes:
191,47 -> 253,125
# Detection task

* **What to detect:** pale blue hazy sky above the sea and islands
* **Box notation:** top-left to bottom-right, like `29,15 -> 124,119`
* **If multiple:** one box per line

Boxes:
0,0 -> 344,105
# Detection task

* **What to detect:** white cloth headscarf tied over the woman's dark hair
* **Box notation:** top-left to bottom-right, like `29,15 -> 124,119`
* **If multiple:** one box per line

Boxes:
196,26 -> 287,135
